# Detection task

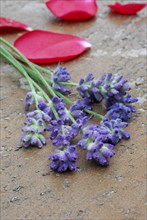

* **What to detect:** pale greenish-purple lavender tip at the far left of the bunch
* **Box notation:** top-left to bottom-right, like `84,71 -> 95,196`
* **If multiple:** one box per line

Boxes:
21,110 -> 50,148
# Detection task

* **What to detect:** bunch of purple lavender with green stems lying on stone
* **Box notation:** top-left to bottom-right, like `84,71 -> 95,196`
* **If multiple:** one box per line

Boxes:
0,38 -> 137,172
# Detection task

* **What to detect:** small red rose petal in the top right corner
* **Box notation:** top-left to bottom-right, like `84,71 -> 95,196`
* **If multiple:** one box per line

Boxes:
108,2 -> 147,15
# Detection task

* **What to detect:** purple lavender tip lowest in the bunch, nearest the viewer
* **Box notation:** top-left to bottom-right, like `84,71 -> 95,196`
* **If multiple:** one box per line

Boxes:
49,146 -> 78,172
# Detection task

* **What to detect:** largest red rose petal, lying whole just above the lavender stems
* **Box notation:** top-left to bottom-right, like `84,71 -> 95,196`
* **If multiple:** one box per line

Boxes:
14,30 -> 91,64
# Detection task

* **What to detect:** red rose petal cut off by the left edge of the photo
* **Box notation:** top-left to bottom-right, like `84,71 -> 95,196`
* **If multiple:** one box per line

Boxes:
0,17 -> 32,34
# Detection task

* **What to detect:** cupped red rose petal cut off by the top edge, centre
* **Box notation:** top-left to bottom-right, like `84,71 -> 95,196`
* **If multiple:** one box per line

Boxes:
46,0 -> 98,20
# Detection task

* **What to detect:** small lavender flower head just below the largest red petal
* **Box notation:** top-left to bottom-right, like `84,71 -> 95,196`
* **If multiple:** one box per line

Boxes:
52,66 -> 70,94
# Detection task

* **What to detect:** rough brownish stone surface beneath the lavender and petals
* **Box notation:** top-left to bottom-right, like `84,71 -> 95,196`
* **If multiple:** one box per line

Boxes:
1,0 -> 147,220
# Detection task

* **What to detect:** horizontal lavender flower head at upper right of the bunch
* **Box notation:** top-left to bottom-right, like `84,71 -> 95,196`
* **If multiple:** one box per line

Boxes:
77,73 -> 130,102
